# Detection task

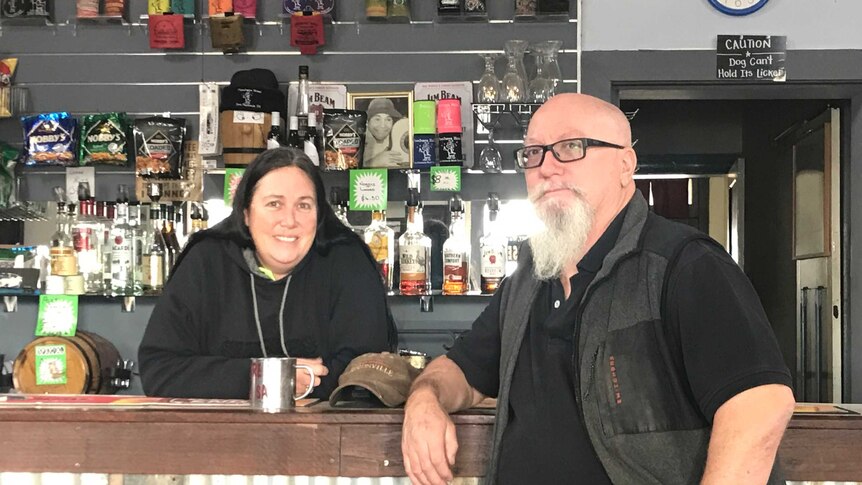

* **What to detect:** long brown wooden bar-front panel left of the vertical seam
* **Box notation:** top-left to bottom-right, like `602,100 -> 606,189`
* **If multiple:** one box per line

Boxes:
0,422 -> 340,476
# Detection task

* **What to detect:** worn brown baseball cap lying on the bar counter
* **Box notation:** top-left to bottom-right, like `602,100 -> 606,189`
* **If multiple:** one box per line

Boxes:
329,352 -> 419,407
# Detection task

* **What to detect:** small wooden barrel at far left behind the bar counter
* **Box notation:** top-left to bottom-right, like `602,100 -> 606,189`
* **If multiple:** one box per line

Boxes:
12,330 -> 120,394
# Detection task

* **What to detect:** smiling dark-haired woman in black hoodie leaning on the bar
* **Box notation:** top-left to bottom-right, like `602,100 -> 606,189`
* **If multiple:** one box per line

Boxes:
138,148 -> 397,398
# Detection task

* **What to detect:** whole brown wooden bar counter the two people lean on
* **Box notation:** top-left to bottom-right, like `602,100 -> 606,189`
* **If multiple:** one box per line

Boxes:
0,403 -> 862,481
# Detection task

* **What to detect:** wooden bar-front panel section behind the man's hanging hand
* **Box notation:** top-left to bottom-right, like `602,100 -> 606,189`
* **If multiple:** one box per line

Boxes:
340,425 -> 493,477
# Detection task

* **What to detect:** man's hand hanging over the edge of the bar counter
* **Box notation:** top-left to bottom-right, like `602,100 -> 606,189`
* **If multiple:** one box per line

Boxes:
401,388 -> 458,485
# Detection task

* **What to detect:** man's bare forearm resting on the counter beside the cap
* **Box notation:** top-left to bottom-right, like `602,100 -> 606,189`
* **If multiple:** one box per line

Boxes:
410,355 -> 485,413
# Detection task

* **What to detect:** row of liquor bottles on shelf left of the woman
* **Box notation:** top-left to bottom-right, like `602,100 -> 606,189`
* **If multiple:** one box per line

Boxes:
41,182 -> 208,296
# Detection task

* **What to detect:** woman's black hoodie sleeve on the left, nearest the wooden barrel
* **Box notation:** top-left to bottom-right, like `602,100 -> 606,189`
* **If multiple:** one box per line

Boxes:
138,241 -> 251,399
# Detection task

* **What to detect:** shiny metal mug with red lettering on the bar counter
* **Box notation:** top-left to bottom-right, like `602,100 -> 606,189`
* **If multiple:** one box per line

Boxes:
249,357 -> 314,413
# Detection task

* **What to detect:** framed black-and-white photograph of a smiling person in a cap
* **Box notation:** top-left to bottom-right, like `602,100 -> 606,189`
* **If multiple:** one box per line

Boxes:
347,91 -> 413,168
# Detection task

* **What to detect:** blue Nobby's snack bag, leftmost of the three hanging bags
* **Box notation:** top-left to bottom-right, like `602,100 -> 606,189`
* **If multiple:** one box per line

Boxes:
21,112 -> 78,166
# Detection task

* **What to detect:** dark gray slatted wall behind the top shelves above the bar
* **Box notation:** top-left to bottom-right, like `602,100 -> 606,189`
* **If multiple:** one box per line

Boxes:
0,0 -> 578,149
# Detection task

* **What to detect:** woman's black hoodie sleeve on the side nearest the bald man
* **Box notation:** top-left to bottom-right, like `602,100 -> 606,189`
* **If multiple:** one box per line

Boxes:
312,244 -> 390,399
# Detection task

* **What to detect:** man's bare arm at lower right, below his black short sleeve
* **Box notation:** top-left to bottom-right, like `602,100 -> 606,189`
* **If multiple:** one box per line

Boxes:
701,384 -> 794,485
